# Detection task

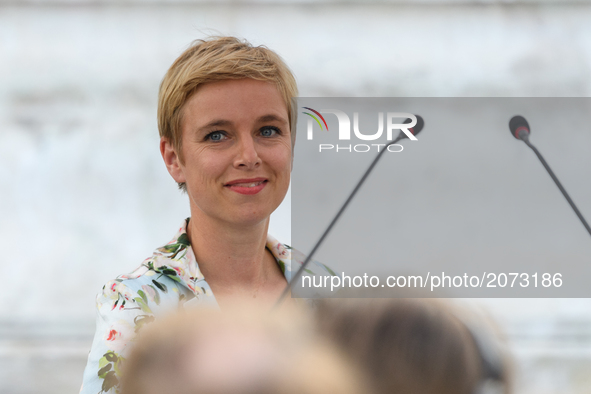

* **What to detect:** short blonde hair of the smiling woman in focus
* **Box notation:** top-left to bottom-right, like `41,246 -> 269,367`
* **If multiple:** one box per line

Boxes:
158,37 -> 298,191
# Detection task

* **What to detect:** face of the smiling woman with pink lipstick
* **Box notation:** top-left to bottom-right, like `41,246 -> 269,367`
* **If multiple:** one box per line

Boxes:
173,79 -> 292,225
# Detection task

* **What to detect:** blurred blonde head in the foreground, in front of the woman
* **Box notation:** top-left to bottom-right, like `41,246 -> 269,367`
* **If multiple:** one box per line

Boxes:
122,305 -> 367,394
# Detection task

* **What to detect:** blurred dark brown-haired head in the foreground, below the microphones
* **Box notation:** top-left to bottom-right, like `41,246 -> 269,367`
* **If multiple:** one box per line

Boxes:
317,299 -> 509,394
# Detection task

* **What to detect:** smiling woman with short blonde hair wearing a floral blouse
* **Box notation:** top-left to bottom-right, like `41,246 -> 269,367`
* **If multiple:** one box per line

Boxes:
81,37 -> 326,394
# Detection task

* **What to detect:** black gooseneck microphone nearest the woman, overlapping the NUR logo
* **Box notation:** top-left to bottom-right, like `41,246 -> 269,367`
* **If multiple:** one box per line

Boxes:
274,115 -> 425,308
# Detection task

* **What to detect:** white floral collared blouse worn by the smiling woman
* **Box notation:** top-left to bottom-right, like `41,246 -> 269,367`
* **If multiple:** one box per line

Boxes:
80,219 -> 335,394
